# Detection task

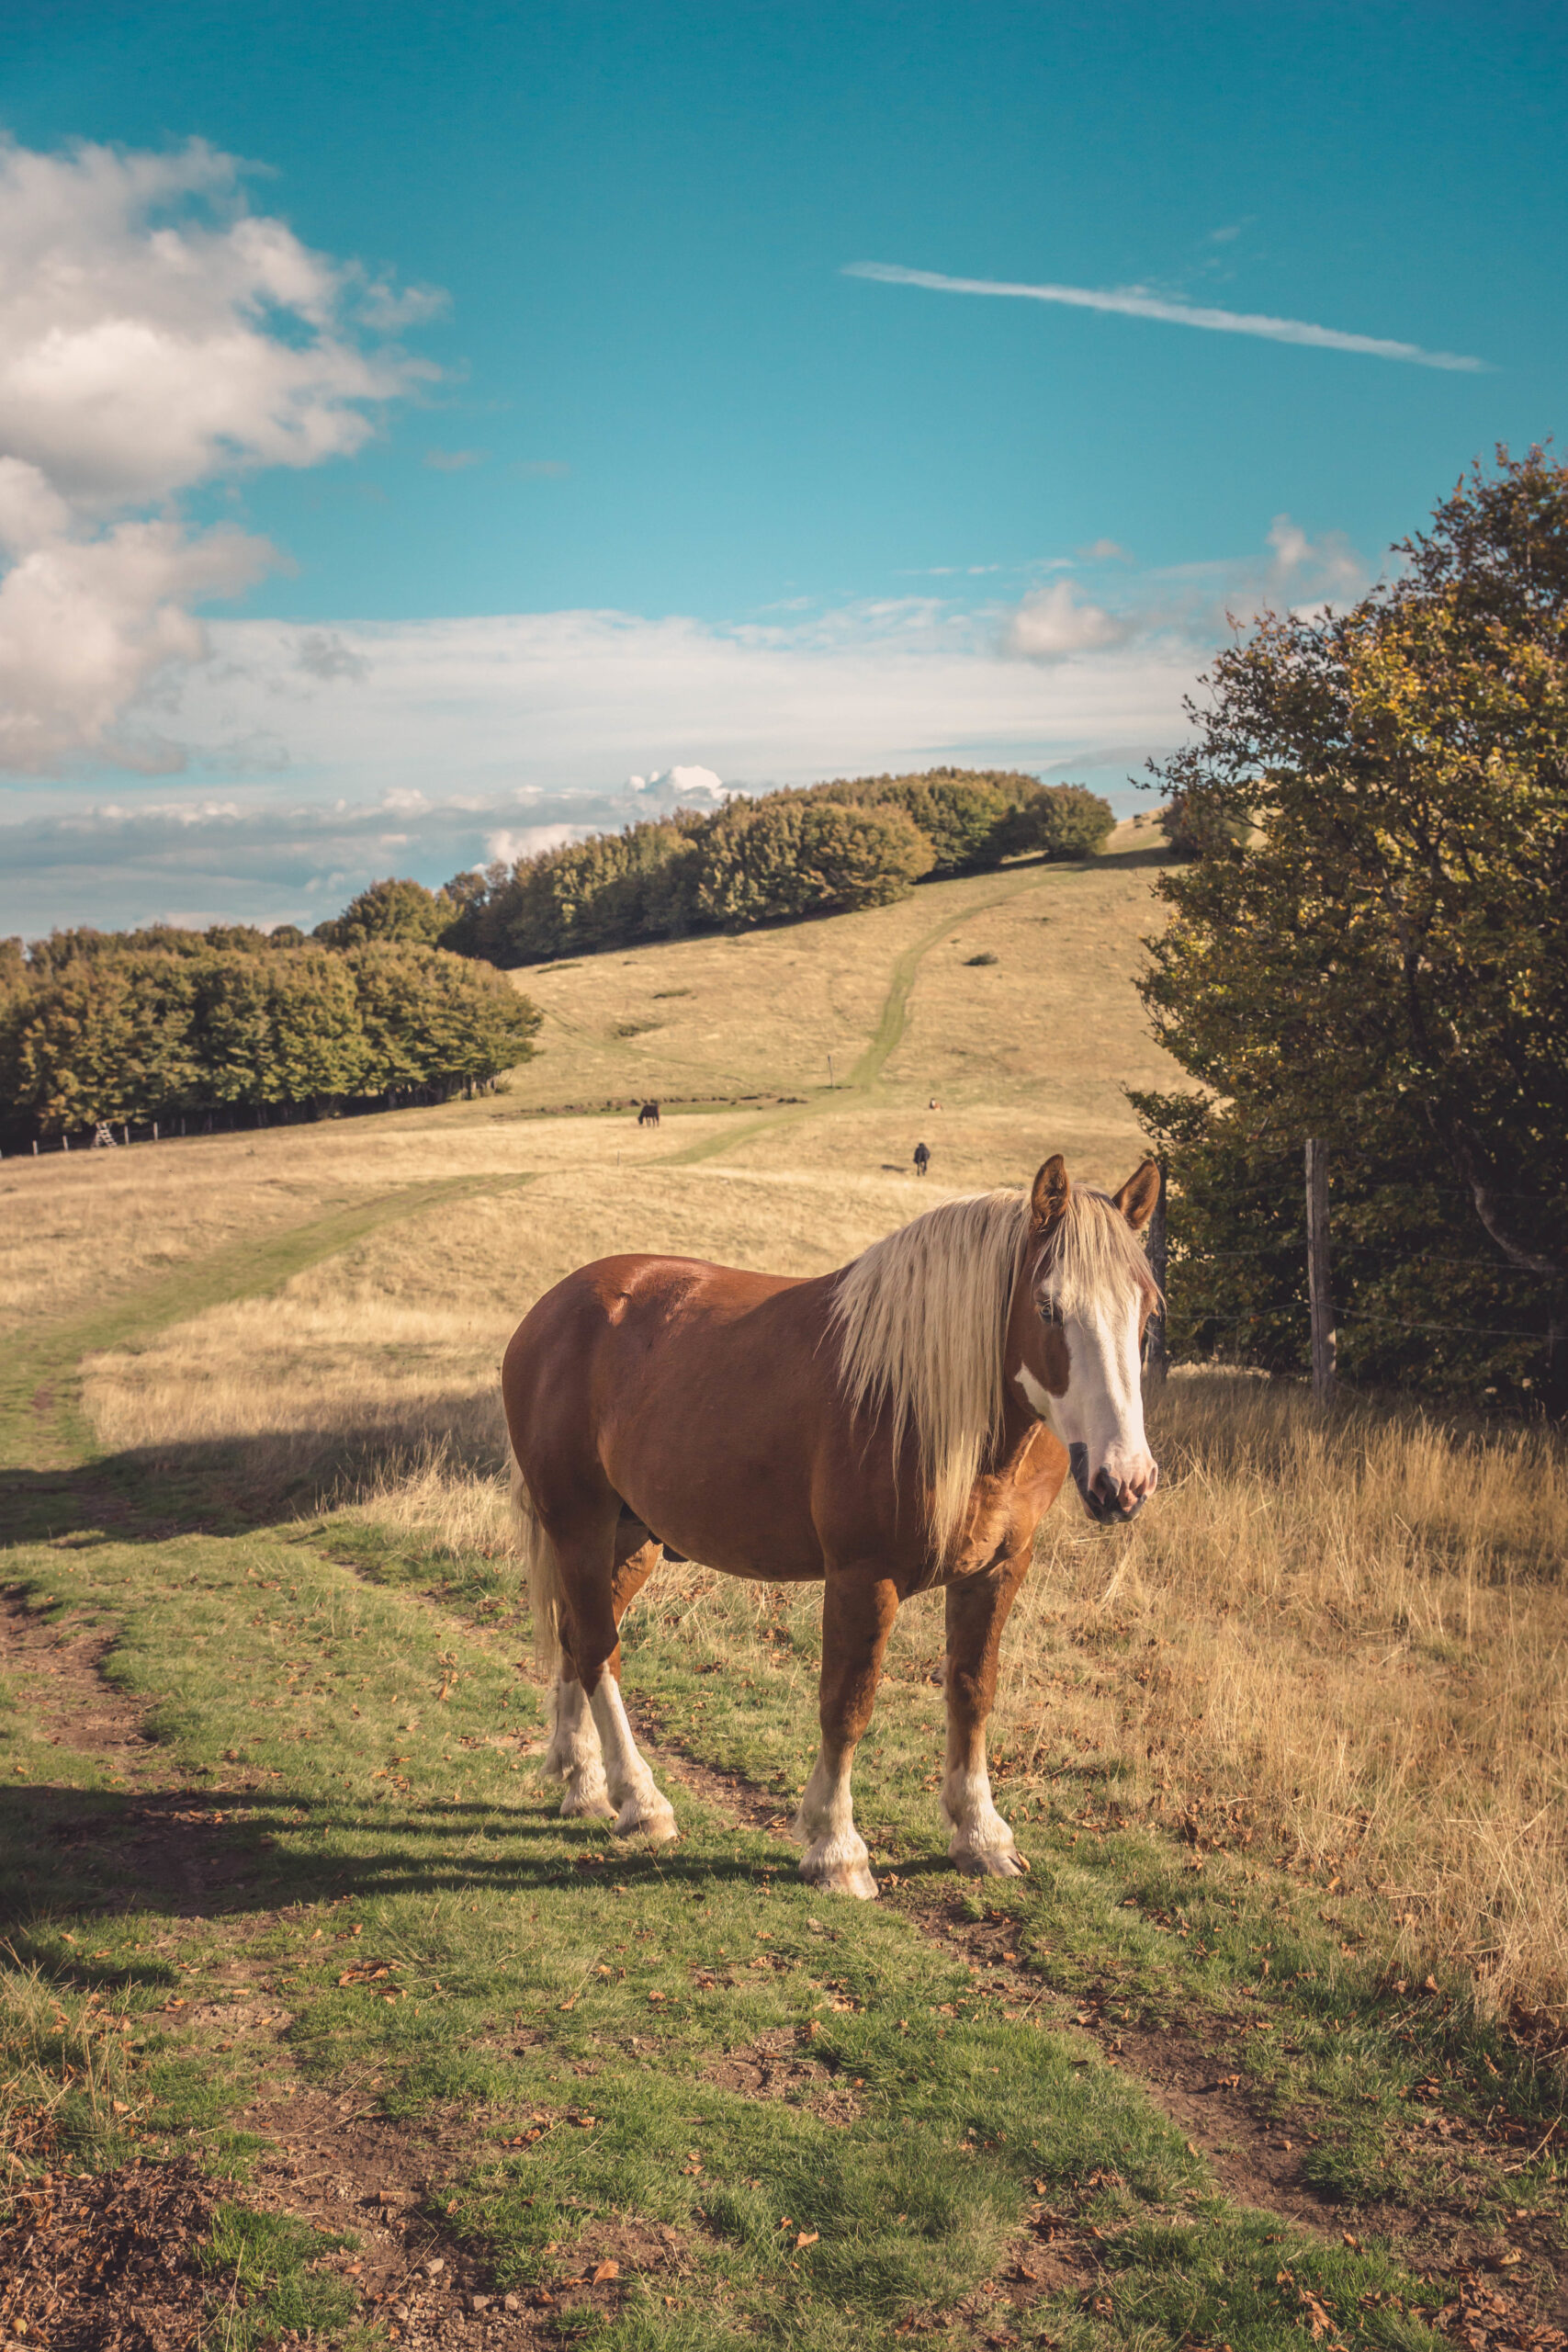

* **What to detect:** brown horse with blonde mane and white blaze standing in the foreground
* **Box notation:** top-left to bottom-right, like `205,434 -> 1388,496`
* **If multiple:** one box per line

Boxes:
501,1155 -> 1159,1895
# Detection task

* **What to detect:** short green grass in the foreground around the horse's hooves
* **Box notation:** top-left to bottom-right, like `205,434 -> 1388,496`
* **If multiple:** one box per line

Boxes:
0,1476 -> 1561,2347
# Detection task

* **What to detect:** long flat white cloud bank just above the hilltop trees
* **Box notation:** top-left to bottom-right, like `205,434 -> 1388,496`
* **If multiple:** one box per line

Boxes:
0,515 -> 1366,933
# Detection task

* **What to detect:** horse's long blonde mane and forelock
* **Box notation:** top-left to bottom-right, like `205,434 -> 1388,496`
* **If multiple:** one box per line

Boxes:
832,1185 -> 1152,1559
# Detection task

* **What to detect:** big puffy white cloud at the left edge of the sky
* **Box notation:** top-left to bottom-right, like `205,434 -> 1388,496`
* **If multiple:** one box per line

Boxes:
0,141 -> 434,774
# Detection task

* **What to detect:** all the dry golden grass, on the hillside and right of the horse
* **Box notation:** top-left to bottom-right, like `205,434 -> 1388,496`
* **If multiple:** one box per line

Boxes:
5,842 -> 1568,2007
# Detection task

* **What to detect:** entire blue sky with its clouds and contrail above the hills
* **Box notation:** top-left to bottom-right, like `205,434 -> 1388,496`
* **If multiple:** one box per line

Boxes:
0,0 -> 1568,929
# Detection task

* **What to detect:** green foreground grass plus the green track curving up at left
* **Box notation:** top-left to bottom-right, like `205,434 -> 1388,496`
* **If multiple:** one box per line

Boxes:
0,1188 -> 1563,2352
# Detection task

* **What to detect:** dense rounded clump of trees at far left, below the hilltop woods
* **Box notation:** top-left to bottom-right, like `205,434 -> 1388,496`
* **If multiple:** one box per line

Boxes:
0,927 -> 541,1136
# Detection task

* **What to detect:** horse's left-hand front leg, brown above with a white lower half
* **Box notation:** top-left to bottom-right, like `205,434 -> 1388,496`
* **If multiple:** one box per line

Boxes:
792,1569 -> 898,1900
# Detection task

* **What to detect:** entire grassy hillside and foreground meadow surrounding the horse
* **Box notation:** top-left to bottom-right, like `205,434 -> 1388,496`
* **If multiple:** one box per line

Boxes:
0,832 -> 1568,2352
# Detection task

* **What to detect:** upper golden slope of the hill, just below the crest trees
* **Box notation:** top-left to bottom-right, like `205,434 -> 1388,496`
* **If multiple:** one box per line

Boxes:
513,826 -> 1180,1185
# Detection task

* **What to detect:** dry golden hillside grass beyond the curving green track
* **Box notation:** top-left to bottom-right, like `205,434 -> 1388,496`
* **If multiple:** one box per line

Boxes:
0,826 -> 1180,1331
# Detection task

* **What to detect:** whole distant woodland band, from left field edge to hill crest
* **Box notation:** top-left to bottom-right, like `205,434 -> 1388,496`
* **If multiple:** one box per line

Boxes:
0,769 -> 1114,1146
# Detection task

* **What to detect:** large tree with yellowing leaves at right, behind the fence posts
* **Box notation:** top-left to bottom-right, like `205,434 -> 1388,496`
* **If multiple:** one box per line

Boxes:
1143,449 -> 1568,1397
